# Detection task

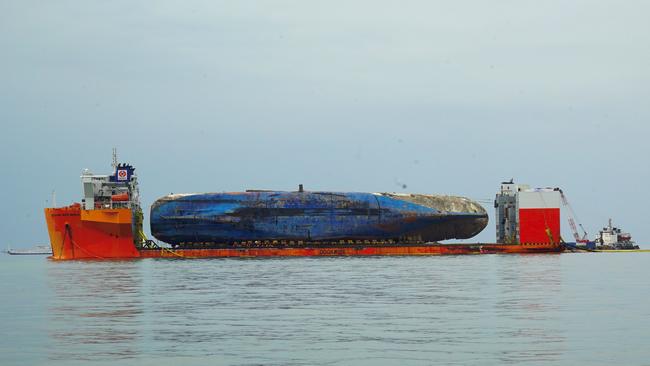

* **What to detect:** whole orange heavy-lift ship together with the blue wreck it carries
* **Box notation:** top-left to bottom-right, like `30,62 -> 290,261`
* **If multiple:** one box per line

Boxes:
45,158 -> 564,260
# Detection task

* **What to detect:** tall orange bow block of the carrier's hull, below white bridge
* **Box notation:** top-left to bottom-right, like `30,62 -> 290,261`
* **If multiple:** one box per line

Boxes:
45,203 -> 140,259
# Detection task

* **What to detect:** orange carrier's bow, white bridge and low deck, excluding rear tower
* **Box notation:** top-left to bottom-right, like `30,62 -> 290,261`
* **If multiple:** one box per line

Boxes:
45,162 -> 563,260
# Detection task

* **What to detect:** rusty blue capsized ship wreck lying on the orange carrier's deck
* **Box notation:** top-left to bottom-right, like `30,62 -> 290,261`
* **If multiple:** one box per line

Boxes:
150,186 -> 488,247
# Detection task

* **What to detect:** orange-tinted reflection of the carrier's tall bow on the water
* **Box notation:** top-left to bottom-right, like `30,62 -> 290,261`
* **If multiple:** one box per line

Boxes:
47,261 -> 144,360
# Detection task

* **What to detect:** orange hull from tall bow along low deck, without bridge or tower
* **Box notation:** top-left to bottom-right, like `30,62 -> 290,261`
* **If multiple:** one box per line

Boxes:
45,204 -> 563,260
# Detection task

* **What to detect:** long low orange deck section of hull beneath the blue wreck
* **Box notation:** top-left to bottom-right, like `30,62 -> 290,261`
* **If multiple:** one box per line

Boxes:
140,244 -> 563,258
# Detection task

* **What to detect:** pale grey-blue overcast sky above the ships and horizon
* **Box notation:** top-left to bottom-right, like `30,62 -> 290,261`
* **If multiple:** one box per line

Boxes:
0,1 -> 650,247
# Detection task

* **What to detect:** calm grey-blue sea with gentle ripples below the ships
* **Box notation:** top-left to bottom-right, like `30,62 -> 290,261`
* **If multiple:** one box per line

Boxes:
0,253 -> 650,366
